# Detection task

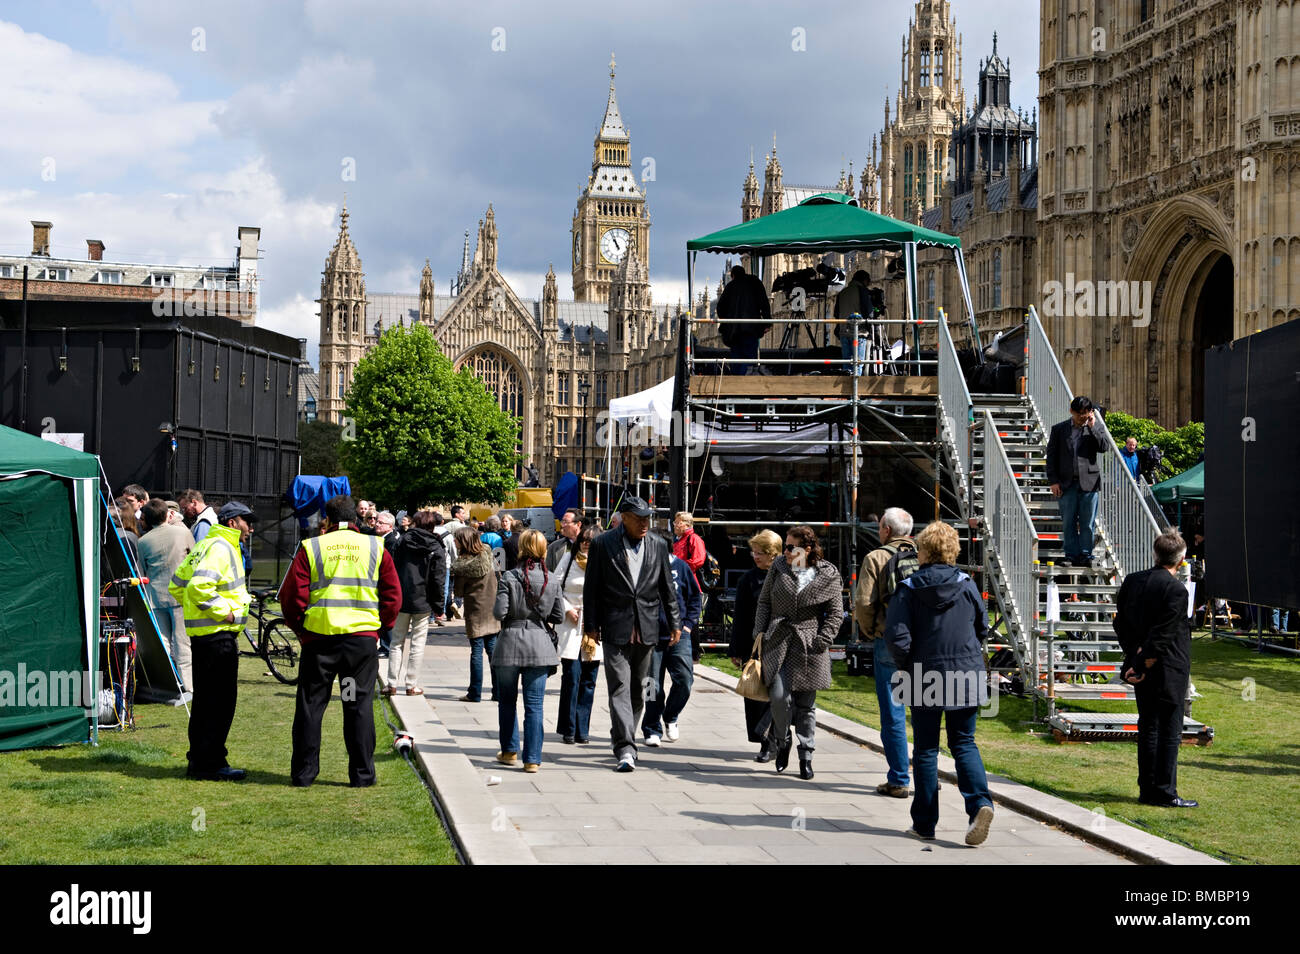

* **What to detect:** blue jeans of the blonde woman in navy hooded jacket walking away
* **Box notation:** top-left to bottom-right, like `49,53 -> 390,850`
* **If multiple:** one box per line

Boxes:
911,706 -> 993,834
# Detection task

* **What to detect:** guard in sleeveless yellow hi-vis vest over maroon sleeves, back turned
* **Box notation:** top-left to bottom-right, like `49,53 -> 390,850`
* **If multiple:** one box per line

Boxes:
280,496 -> 402,788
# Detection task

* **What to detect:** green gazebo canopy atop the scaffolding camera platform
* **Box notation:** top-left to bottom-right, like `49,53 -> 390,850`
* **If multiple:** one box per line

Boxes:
686,192 -> 962,253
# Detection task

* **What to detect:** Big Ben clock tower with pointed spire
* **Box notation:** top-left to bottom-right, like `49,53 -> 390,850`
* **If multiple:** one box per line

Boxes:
573,53 -> 650,302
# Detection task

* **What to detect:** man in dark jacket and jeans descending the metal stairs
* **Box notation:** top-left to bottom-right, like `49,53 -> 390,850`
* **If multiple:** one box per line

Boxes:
1048,395 -> 1101,567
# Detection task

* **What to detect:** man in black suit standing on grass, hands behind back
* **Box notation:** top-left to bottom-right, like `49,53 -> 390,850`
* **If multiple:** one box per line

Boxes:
1114,530 -> 1196,808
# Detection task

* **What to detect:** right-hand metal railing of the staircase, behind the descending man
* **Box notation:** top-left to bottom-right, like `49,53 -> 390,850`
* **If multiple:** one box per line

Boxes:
1024,305 -> 1160,580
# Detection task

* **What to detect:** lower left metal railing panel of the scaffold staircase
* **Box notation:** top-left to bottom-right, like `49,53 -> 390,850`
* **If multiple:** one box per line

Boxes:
982,409 -> 1039,659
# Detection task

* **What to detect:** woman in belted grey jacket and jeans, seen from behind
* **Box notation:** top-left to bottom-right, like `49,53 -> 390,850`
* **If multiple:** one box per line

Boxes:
491,530 -> 564,772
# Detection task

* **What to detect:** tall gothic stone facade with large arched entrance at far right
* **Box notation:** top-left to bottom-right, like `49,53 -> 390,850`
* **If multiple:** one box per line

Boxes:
1037,0 -> 1300,426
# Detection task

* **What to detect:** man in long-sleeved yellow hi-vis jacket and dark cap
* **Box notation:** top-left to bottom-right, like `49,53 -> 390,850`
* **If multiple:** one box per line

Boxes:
168,500 -> 257,781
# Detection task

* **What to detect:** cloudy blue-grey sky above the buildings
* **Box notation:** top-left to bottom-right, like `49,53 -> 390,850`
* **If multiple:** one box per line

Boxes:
0,0 -> 1037,360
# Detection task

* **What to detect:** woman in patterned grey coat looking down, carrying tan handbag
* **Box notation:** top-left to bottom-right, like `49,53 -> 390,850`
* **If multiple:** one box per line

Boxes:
754,526 -> 844,779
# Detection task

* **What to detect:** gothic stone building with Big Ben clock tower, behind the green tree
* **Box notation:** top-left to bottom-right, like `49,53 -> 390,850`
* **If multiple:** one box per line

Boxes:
317,64 -> 680,485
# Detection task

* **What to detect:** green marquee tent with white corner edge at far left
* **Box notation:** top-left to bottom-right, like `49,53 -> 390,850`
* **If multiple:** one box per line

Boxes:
0,426 -> 99,750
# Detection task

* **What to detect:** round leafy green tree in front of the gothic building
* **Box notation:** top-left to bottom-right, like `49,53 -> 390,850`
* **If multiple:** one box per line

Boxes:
341,325 -> 521,509
